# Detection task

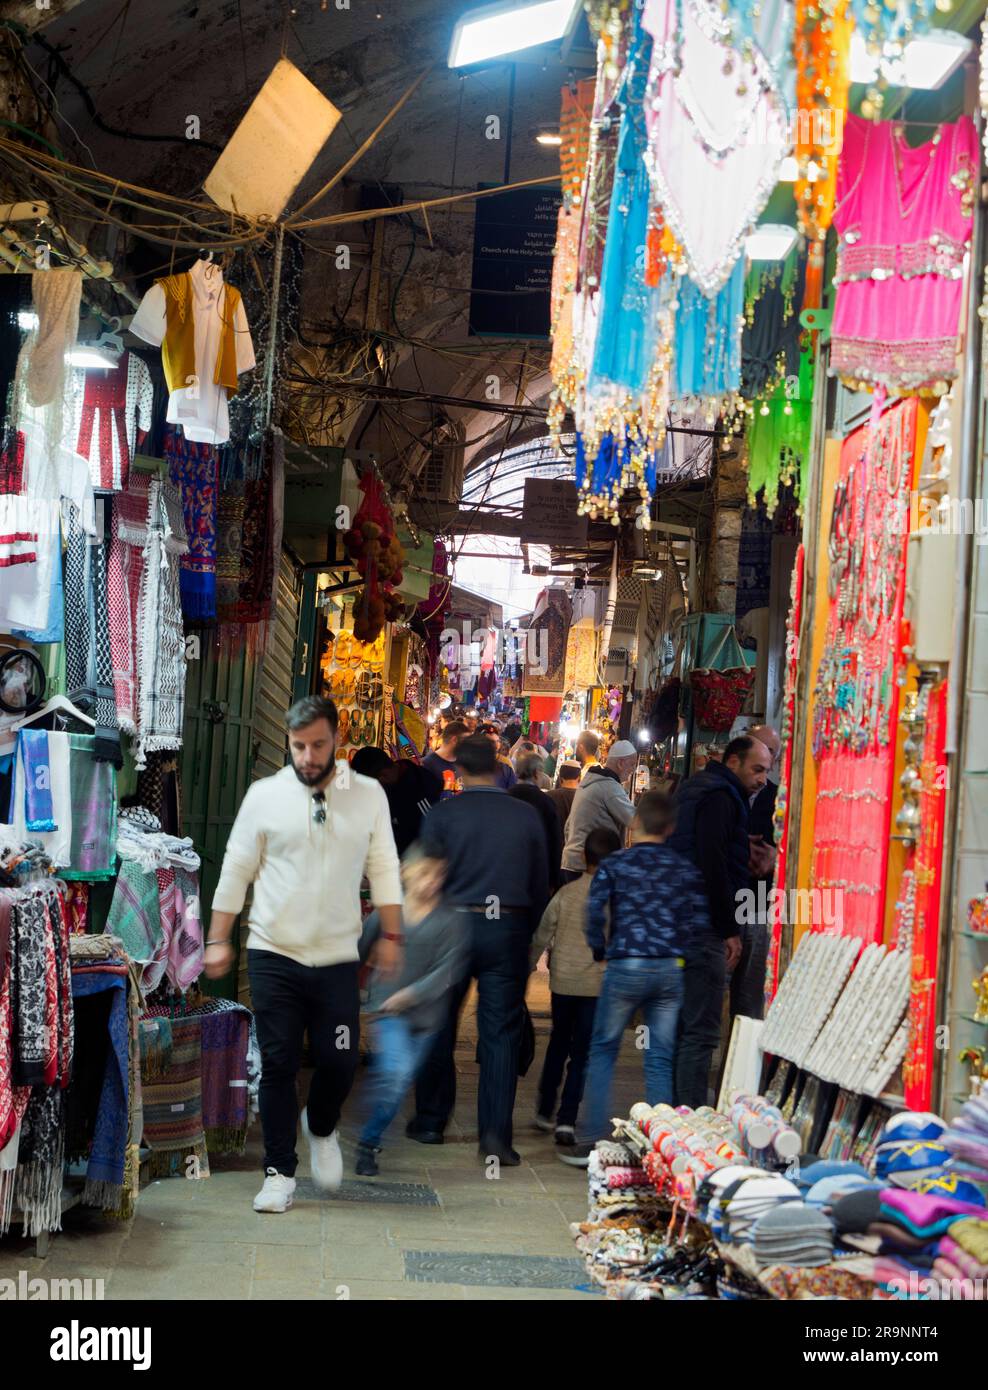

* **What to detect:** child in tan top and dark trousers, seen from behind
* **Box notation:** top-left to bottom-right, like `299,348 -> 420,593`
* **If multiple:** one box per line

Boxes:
529,828 -> 621,1144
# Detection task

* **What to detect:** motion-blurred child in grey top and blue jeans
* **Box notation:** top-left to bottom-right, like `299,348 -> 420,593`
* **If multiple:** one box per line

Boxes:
356,841 -> 470,1177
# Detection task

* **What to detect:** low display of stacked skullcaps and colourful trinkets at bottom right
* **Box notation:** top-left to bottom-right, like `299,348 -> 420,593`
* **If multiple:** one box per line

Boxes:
571,1091 -> 988,1301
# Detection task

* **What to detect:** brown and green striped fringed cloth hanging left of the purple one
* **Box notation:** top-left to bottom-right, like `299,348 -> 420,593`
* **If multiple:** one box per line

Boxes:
145,1017 -> 208,1177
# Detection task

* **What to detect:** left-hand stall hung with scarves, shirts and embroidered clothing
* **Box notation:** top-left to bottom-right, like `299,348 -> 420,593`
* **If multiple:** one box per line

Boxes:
0,244 -> 270,1248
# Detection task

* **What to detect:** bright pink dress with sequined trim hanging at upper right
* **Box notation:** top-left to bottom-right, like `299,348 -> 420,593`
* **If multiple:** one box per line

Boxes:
831,115 -> 978,395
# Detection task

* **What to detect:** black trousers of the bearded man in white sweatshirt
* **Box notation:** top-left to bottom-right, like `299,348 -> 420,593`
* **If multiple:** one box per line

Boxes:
247,951 -> 360,1177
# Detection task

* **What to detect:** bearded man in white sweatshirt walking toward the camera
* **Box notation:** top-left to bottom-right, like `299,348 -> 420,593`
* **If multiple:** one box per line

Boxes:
206,696 -> 402,1212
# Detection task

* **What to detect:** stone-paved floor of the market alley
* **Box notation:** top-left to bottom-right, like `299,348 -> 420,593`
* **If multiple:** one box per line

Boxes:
0,973 -> 650,1300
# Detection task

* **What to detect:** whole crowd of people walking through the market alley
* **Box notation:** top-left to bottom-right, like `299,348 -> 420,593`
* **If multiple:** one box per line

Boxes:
206,698 -> 780,1212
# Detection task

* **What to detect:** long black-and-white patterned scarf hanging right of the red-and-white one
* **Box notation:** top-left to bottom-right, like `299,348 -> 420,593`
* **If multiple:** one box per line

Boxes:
136,480 -> 185,769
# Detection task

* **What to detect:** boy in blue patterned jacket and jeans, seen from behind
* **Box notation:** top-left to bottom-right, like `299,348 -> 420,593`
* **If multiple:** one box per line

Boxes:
559,791 -> 710,1166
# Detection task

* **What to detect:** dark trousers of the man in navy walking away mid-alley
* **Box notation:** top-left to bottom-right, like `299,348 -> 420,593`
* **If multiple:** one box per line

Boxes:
413,910 -> 532,1152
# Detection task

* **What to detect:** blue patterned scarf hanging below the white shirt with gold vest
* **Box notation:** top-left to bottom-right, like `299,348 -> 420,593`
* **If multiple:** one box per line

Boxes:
164,425 -> 220,623
